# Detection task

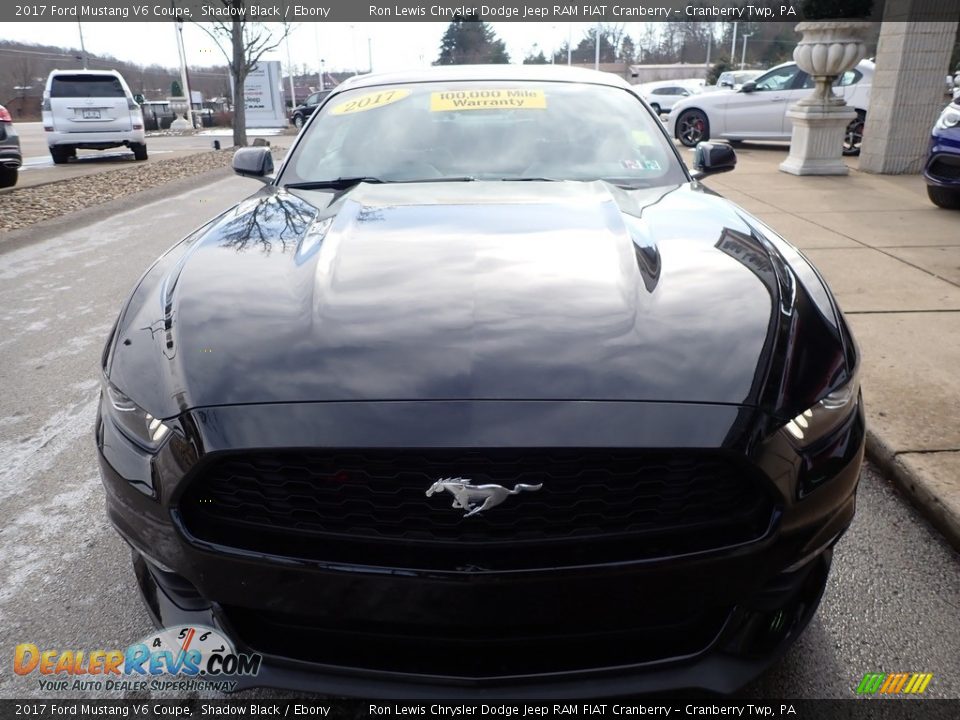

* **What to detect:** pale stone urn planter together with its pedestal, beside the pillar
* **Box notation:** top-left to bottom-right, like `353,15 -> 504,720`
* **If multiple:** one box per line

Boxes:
780,20 -> 870,175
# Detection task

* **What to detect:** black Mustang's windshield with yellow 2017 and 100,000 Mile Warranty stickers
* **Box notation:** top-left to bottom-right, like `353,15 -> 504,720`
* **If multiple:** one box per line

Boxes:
280,81 -> 687,187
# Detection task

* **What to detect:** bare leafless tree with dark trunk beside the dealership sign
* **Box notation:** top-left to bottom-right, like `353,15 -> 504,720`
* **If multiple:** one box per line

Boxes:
196,0 -> 291,147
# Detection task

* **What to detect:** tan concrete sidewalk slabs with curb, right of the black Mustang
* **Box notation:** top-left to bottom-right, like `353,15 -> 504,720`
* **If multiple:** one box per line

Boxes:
696,144 -> 960,549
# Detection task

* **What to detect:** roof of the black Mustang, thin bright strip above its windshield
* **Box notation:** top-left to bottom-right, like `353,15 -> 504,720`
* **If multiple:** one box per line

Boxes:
336,65 -> 631,90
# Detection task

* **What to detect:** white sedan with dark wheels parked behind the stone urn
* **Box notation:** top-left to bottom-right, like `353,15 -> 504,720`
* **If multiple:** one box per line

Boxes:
667,60 -> 874,155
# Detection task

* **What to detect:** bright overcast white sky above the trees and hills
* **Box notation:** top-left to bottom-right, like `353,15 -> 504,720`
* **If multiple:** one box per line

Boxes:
0,22 -> 644,72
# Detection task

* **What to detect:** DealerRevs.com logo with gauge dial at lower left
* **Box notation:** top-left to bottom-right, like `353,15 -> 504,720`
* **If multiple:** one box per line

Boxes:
13,625 -> 263,691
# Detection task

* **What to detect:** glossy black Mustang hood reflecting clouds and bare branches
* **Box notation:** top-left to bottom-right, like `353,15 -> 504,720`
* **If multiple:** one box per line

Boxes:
110,182 -> 836,417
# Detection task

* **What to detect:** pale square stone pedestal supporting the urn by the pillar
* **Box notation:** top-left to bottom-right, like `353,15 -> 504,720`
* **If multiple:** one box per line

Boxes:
780,103 -> 857,175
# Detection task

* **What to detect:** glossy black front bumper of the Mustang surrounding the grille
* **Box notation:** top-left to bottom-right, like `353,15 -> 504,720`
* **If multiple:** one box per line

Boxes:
98,396 -> 863,698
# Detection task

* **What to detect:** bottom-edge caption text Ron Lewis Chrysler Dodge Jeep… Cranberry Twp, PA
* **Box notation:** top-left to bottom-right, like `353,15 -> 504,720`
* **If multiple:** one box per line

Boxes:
369,703 -> 796,718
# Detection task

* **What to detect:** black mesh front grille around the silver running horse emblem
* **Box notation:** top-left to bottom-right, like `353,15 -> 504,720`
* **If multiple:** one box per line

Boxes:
179,449 -> 776,569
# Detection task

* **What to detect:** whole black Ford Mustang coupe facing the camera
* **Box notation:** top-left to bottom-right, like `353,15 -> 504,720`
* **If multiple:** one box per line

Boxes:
96,66 -> 864,697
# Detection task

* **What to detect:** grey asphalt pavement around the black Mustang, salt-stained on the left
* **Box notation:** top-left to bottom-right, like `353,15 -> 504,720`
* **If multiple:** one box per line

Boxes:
0,172 -> 960,699
